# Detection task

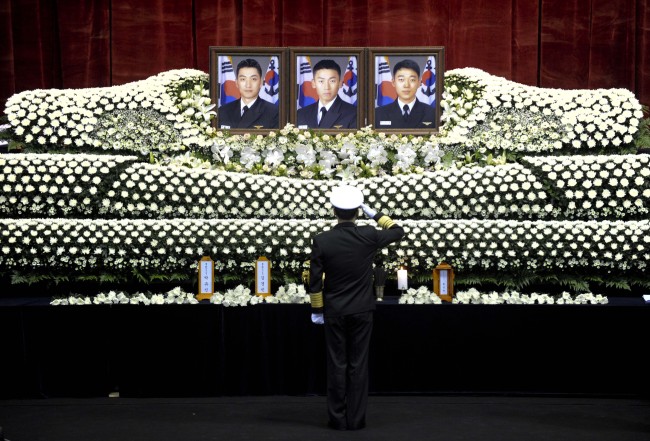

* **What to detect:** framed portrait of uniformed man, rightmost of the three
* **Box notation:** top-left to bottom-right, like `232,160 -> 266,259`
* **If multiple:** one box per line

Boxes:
368,47 -> 445,134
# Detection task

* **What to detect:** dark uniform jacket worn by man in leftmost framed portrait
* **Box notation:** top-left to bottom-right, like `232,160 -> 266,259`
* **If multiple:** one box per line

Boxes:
219,97 -> 279,129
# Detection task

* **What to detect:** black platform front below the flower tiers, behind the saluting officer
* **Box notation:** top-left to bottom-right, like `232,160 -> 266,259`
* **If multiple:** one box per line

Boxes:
0,297 -> 650,399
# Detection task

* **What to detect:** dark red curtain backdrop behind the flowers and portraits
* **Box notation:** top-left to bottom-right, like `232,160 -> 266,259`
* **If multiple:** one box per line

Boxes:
0,0 -> 650,107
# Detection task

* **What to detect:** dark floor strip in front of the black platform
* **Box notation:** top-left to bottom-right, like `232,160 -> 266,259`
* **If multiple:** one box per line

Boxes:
0,396 -> 650,441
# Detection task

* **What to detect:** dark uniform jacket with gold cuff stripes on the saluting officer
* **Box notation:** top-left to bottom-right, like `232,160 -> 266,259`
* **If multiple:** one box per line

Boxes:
309,213 -> 404,317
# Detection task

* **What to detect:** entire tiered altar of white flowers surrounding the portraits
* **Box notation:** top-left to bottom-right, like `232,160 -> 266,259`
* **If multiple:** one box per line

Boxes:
0,69 -> 650,304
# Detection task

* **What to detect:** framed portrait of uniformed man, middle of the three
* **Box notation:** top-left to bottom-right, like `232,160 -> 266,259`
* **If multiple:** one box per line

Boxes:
289,47 -> 366,133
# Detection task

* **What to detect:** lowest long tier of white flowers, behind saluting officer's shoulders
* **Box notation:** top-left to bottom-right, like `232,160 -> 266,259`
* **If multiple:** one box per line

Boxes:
0,219 -> 650,275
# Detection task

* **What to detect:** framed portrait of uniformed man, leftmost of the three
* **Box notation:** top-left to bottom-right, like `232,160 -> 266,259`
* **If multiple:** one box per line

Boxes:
210,46 -> 288,133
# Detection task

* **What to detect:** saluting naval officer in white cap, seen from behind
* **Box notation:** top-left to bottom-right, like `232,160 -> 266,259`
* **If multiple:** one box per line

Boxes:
309,186 -> 404,430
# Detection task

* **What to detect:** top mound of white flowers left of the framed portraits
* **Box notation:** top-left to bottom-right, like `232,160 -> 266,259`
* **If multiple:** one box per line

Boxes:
5,69 -> 215,153
